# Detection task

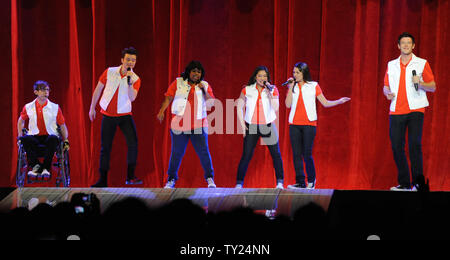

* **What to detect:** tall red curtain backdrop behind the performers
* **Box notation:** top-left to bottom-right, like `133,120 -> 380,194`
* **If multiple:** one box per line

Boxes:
0,0 -> 450,190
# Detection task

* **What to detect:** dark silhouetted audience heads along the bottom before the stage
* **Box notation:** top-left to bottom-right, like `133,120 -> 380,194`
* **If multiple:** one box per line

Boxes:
0,184 -> 450,242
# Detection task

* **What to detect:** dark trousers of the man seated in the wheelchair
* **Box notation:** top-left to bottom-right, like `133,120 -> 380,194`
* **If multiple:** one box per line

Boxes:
20,135 -> 59,172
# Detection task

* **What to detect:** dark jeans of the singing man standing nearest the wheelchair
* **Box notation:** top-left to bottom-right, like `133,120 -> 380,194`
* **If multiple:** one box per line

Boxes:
99,115 -> 138,179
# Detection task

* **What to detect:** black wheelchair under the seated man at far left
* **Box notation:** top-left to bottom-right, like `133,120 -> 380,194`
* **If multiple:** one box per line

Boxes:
16,127 -> 70,188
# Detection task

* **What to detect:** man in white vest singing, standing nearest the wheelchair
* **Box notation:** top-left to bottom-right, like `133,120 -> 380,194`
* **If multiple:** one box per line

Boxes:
89,47 -> 142,187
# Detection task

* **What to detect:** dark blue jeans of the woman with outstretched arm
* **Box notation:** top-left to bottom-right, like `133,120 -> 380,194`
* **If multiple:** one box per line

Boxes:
289,125 -> 316,184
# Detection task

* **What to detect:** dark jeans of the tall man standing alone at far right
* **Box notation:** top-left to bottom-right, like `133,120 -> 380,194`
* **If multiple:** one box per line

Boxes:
389,112 -> 424,187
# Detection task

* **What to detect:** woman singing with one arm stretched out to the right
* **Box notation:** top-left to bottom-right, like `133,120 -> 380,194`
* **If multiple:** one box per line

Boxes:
285,62 -> 350,189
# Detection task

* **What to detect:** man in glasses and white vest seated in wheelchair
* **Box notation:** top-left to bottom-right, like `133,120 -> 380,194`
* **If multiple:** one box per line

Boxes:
17,80 -> 69,178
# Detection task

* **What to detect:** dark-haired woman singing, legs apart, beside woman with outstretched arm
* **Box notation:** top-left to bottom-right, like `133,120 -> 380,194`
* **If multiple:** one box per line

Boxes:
235,66 -> 284,189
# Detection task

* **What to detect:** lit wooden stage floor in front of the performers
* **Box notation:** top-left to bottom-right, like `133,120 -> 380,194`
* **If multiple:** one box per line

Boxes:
0,188 -> 334,216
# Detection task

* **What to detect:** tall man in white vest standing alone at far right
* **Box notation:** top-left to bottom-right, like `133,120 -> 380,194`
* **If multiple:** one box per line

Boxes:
383,32 -> 436,191
